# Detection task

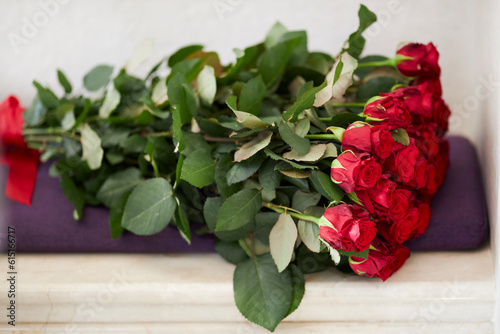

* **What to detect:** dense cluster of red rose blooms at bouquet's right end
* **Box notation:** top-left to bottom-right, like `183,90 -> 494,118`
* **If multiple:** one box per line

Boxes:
320,44 -> 450,280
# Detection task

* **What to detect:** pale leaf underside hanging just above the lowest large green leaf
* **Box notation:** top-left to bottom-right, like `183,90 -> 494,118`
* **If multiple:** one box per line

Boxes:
269,213 -> 297,272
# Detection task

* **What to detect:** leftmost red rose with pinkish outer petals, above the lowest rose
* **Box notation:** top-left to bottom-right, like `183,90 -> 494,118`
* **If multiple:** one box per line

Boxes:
319,204 -> 377,252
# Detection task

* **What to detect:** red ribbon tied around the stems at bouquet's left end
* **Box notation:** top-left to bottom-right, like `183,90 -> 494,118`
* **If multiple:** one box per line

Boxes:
0,96 -> 39,205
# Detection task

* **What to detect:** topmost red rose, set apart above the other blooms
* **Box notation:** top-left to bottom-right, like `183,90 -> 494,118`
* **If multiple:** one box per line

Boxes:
396,43 -> 441,78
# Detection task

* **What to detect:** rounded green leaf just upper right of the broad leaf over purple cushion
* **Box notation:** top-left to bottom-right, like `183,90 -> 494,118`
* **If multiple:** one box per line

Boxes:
181,149 -> 215,188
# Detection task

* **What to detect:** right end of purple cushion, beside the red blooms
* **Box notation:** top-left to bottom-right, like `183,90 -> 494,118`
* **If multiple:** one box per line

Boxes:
406,136 -> 489,251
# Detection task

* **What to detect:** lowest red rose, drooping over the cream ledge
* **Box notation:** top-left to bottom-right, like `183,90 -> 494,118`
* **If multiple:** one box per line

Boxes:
349,238 -> 410,281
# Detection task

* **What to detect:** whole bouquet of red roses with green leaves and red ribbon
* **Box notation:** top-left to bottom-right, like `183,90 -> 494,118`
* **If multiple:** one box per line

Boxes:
0,6 -> 450,330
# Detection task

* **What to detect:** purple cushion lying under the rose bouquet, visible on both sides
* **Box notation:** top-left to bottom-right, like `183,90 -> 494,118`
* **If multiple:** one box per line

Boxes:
0,136 -> 488,253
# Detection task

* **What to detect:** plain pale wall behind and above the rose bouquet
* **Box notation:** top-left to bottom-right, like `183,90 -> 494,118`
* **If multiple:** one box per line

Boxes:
0,0 -> 500,328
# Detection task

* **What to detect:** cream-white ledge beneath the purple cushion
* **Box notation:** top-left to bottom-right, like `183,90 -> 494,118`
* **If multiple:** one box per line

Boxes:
0,247 -> 495,334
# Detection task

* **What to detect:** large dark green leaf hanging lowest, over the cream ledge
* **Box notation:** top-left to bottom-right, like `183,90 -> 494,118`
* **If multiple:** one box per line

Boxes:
233,254 -> 293,331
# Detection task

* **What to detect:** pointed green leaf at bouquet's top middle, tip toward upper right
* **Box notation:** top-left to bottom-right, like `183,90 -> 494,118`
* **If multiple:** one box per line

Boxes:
257,36 -> 303,87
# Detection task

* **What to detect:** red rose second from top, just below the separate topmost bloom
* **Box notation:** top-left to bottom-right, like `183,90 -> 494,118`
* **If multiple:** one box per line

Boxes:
364,87 -> 420,128
